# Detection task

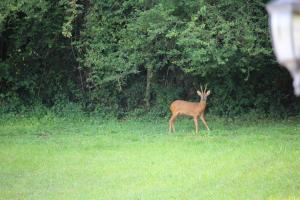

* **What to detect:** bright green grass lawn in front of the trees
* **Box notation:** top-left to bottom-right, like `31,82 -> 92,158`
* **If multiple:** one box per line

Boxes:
0,115 -> 300,200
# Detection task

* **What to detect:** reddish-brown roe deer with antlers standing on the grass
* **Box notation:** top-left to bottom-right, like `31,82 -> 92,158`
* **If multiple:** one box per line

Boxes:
169,86 -> 210,133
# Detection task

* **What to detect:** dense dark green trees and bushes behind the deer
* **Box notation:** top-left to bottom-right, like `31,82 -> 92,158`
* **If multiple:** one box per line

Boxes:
0,0 -> 300,117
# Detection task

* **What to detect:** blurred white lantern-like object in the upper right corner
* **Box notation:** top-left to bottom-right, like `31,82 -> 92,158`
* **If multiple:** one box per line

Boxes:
267,0 -> 300,96
